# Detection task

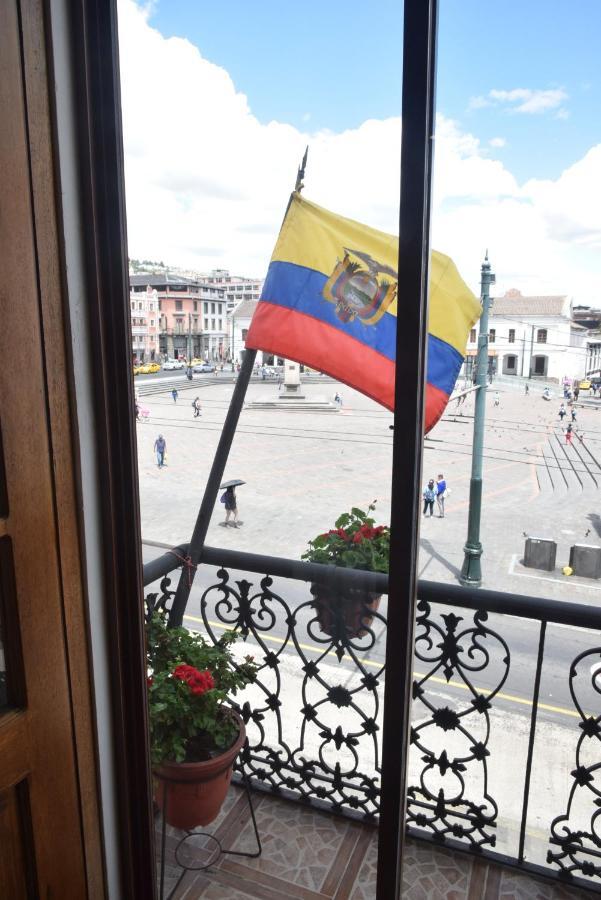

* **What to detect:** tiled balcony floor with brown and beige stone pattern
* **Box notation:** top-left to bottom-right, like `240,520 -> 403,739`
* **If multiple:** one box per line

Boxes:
157,788 -> 591,900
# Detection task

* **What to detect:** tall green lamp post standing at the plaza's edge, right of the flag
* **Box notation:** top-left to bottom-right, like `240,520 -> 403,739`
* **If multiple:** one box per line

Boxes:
459,251 -> 495,587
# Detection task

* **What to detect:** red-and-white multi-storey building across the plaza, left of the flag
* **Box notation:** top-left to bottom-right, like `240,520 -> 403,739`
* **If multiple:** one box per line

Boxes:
130,275 -> 227,362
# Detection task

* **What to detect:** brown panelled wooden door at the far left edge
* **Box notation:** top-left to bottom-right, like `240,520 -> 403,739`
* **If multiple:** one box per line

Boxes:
0,0 -> 104,900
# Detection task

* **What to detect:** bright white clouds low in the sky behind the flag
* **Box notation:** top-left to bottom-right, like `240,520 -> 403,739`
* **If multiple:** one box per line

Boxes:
119,0 -> 601,302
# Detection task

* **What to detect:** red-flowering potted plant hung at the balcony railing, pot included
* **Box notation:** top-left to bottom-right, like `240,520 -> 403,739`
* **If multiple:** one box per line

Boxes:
301,501 -> 390,639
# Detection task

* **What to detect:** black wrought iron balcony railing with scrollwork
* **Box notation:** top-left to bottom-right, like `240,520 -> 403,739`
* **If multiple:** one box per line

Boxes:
144,545 -> 601,888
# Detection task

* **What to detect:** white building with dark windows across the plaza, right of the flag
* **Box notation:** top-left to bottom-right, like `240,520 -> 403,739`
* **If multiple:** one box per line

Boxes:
466,290 -> 587,382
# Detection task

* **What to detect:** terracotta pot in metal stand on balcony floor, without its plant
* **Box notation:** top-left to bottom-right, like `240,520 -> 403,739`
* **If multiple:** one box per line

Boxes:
154,710 -> 246,830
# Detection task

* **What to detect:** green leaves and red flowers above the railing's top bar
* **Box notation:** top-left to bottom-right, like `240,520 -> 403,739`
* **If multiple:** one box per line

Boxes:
301,500 -> 390,572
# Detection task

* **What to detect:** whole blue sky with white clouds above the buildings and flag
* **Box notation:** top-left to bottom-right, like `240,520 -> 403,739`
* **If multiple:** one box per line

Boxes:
119,0 -> 601,305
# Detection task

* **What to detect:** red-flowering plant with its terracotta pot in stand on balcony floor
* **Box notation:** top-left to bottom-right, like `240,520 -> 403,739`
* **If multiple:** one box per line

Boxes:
146,612 -> 256,829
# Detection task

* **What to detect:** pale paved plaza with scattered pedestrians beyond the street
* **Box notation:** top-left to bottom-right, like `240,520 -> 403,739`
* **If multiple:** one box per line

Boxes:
138,379 -> 601,603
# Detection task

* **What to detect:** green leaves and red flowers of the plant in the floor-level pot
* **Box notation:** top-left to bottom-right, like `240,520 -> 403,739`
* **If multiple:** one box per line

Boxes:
146,612 -> 257,765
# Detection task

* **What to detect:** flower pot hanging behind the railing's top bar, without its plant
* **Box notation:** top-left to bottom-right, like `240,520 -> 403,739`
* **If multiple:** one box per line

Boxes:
311,583 -> 382,638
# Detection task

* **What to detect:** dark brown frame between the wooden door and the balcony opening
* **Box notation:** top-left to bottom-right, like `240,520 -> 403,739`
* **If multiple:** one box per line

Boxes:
44,0 -> 156,900
